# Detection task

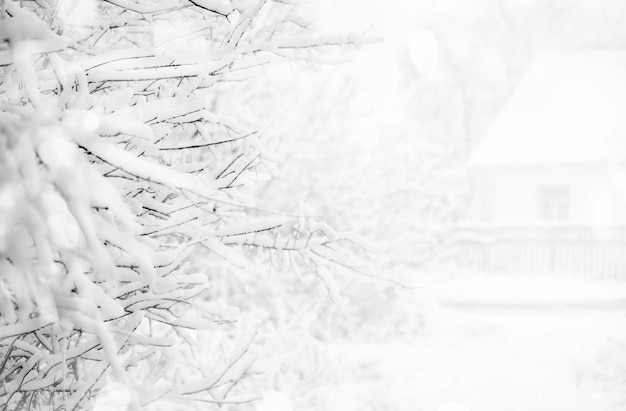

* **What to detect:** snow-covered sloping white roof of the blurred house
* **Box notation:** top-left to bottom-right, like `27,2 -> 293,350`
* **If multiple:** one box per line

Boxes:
471,51 -> 626,166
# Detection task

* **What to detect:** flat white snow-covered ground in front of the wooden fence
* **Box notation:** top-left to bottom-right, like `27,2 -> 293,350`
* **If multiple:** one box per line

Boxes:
314,277 -> 626,411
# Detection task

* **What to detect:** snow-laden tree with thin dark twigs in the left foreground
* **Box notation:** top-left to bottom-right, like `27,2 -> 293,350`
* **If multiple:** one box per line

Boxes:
0,0 -> 370,410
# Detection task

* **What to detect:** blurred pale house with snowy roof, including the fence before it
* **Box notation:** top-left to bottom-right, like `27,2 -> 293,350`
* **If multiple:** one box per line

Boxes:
463,51 -> 626,278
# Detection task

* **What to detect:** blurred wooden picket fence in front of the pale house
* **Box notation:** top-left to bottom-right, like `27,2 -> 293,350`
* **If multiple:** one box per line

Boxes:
448,224 -> 626,279
